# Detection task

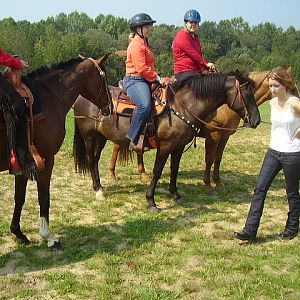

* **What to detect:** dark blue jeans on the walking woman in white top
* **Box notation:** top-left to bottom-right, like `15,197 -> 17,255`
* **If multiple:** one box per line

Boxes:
243,148 -> 300,235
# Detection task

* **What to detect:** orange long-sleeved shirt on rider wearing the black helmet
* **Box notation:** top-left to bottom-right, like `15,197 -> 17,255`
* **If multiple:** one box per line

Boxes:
125,36 -> 157,82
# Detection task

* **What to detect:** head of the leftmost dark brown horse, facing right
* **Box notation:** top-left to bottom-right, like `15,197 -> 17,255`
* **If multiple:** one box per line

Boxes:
80,54 -> 113,115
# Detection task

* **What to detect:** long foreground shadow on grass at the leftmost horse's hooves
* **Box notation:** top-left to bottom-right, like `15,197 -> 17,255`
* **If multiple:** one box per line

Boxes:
0,207 -> 219,275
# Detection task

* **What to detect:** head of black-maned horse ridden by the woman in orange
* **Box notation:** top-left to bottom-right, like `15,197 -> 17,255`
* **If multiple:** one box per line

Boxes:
225,70 -> 260,128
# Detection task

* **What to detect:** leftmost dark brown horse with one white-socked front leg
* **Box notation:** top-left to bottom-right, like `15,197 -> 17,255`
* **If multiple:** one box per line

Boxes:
2,55 -> 112,247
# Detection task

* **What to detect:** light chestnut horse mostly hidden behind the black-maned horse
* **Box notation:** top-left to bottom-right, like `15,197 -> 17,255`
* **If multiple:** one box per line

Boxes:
108,68 -> 278,193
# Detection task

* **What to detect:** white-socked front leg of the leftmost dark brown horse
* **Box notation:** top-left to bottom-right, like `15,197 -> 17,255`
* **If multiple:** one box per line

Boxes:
37,157 -> 62,248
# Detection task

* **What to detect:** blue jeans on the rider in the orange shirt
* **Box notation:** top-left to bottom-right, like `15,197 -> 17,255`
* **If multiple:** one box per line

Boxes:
123,75 -> 152,144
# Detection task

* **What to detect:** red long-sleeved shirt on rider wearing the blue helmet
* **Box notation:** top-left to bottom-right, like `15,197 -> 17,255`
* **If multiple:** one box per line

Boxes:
172,29 -> 208,74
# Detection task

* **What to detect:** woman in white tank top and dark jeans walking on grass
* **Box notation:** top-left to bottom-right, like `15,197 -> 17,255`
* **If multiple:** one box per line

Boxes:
234,68 -> 300,241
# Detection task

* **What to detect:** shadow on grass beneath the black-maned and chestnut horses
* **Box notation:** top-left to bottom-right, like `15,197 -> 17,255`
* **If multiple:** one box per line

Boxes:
105,171 -> 285,207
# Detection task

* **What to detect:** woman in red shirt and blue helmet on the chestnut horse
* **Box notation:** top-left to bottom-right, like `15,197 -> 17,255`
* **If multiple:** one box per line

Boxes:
172,9 -> 215,80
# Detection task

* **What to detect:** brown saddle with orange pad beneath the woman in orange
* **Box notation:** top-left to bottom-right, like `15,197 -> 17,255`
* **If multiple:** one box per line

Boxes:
109,80 -> 167,152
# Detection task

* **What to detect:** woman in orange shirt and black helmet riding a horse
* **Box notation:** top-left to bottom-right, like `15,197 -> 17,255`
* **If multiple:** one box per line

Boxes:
123,13 -> 162,151
